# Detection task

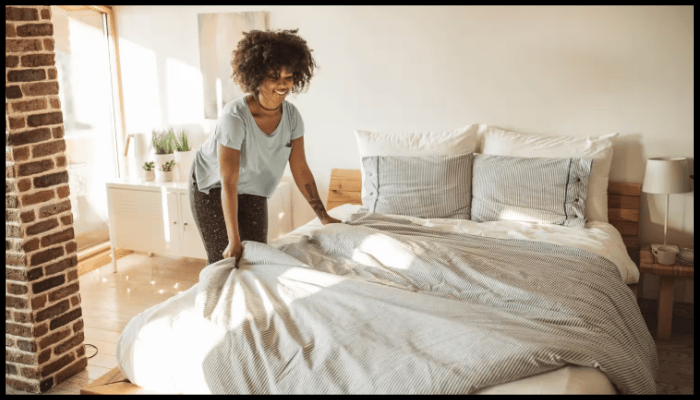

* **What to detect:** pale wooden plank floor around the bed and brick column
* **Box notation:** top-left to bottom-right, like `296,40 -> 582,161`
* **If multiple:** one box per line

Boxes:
5,253 -> 694,394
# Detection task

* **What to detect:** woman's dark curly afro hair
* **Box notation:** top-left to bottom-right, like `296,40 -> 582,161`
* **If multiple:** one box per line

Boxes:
231,29 -> 316,93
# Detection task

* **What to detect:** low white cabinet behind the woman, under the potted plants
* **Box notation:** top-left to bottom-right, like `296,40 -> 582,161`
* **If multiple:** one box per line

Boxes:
107,180 -> 292,272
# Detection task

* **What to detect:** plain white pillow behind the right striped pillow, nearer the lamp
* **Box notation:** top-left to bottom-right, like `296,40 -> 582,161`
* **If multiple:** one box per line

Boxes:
479,124 -> 617,222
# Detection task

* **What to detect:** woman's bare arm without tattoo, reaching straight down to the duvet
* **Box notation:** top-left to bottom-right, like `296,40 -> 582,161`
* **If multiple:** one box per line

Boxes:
217,144 -> 243,262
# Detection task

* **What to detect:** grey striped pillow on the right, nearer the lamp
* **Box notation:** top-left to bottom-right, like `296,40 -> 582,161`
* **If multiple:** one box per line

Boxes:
471,154 -> 593,227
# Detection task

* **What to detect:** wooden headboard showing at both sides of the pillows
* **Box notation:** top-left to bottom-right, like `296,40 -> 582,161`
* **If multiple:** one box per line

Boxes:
326,169 -> 642,265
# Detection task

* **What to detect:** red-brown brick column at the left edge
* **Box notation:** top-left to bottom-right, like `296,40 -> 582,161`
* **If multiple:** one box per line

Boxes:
5,6 -> 87,393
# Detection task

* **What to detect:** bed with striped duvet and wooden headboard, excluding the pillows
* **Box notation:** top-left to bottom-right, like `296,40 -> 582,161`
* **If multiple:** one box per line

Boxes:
100,126 -> 658,394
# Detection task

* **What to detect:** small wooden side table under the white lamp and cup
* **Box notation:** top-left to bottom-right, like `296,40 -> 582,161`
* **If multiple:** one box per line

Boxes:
639,245 -> 693,340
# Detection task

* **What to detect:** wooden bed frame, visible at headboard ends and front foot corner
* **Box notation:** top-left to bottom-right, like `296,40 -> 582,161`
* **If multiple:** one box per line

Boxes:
80,169 -> 642,394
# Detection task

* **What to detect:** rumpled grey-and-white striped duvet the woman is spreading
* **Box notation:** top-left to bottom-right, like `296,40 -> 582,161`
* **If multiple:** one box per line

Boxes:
194,213 -> 657,393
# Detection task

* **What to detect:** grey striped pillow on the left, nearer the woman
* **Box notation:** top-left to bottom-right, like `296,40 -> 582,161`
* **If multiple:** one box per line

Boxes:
362,152 -> 474,219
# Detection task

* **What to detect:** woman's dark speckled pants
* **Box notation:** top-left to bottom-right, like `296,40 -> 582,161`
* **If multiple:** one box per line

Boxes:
189,165 -> 267,265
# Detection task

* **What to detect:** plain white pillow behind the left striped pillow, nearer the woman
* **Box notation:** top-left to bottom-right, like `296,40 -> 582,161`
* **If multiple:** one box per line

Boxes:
355,124 -> 479,197
